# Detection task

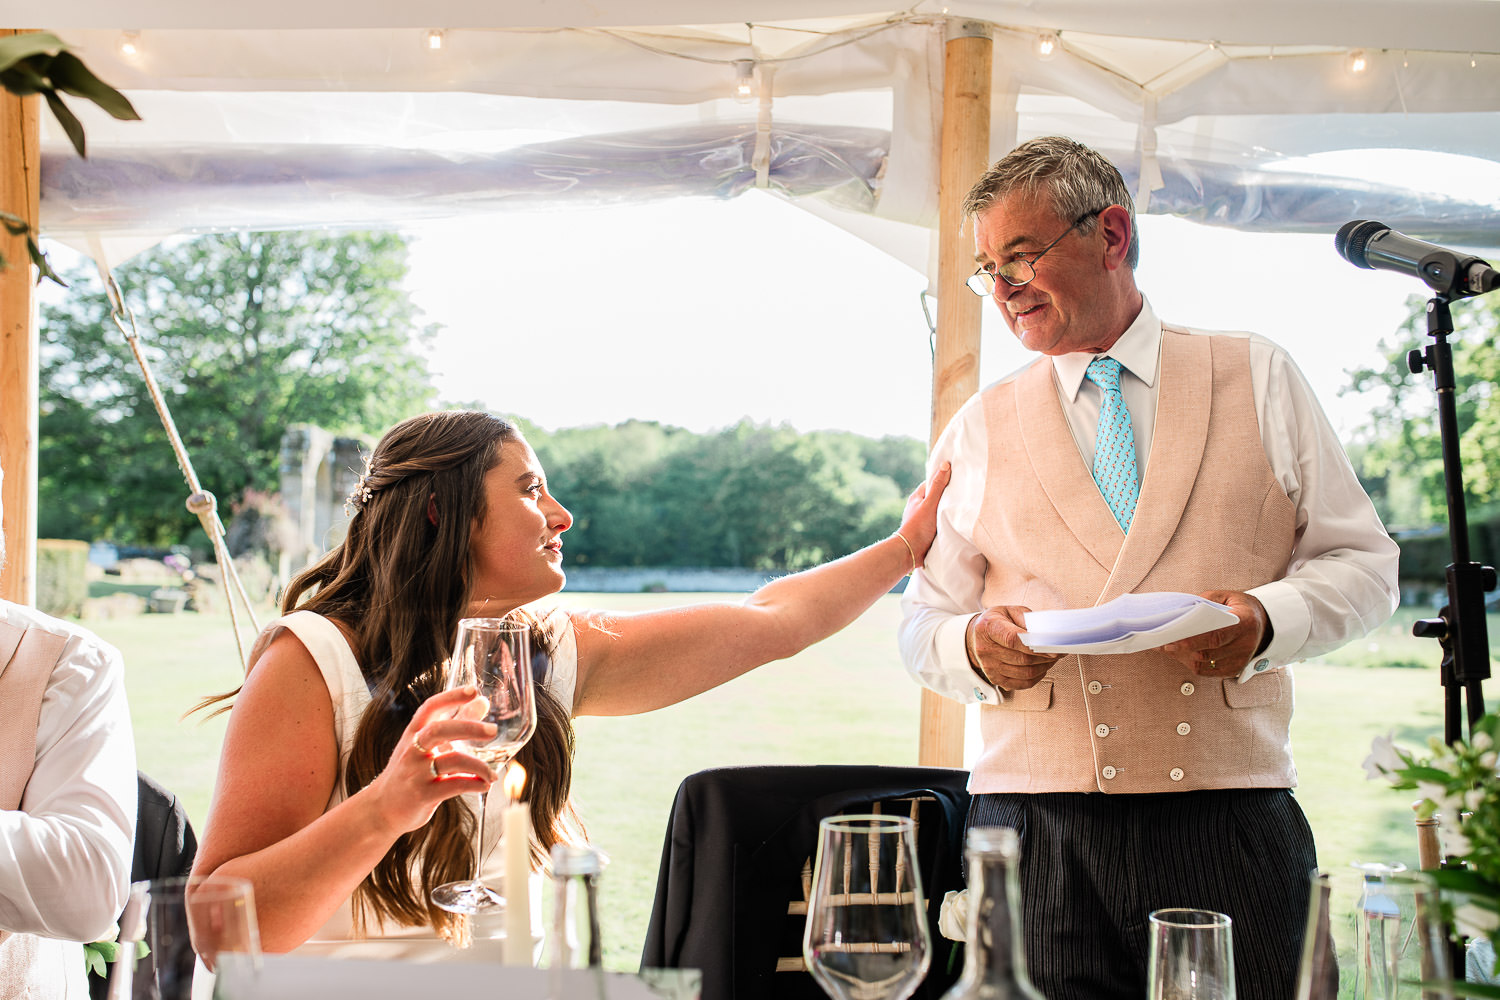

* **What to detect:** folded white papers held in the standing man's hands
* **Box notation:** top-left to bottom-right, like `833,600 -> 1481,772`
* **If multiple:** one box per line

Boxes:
1022,591 -> 1239,654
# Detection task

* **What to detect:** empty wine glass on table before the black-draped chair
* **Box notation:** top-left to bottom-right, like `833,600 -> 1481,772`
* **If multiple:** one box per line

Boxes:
803,816 -> 932,1000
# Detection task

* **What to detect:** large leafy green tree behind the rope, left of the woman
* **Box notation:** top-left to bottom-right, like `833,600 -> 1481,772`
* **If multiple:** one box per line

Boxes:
39,232 -> 435,544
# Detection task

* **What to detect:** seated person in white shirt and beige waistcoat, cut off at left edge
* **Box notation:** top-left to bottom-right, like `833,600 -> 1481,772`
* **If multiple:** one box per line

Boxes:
0,471 -> 137,1000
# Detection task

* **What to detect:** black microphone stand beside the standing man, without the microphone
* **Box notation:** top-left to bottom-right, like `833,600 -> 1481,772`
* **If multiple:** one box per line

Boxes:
1407,292 -> 1496,982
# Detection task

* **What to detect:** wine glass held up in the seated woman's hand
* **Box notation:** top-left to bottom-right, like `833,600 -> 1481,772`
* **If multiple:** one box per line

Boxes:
432,618 -> 537,915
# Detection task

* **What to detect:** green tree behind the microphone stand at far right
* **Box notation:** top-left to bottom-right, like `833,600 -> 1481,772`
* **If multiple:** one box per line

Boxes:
1347,295 -> 1500,526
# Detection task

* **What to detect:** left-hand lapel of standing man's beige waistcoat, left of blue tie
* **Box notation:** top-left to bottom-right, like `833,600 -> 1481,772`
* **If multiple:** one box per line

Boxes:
1016,358 -> 1125,571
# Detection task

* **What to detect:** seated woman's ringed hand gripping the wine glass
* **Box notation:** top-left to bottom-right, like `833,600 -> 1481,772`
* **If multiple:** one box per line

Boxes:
366,687 -> 498,837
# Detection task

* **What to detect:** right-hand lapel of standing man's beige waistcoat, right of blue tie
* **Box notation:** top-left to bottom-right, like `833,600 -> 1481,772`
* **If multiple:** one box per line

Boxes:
1100,328 -> 1214,604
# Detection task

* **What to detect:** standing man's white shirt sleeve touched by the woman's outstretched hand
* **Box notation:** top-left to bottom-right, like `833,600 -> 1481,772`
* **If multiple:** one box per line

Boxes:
897,396 -> 1002,703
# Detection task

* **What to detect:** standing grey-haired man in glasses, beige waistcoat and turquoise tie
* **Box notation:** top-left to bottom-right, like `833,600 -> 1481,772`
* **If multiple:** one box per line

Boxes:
902,138 -> 1397,1000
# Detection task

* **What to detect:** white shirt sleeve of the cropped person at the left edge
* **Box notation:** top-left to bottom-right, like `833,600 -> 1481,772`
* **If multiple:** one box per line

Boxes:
0,622 -> 137,942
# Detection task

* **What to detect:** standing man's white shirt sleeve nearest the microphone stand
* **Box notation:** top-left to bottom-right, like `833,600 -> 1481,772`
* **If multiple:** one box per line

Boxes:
1250,337 -> 1400,669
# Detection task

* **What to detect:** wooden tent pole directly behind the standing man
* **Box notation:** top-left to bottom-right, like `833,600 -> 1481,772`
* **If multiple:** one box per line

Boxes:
918,21 -> 995,768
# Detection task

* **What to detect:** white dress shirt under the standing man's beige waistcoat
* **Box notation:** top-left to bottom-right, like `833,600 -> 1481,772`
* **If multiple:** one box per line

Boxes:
900,296 -> 1400,703
